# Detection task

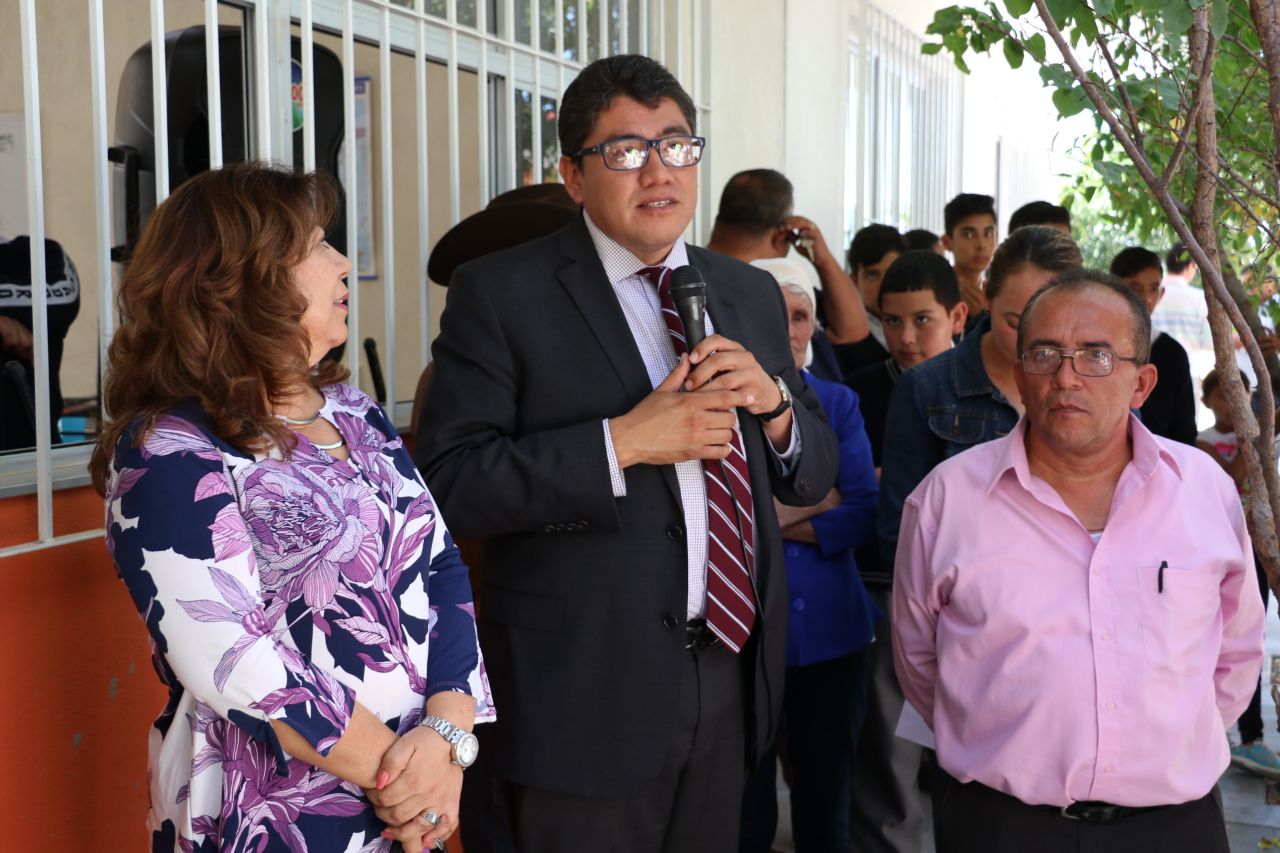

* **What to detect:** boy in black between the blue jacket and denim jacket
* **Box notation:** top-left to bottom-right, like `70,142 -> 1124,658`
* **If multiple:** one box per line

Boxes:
847,250 -> 968,850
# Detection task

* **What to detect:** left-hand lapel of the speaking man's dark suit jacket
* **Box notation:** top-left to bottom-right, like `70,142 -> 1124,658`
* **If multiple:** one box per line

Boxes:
558,216 -> 681,503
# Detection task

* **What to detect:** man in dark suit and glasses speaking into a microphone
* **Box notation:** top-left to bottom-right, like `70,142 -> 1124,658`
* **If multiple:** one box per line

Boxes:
417,56 -> 838,853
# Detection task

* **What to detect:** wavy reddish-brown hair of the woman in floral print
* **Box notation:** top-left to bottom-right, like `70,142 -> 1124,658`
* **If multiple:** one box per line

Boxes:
88,163 -> 348,493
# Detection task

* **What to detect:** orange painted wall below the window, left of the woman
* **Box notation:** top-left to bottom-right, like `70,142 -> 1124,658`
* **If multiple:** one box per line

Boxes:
0,488 -> 462,853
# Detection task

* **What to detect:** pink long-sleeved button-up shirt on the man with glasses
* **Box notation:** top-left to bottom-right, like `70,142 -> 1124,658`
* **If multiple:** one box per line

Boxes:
893,418 -> 1263,806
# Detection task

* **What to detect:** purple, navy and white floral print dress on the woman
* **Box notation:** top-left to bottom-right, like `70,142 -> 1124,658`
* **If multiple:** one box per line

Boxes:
106,386 -> 494,853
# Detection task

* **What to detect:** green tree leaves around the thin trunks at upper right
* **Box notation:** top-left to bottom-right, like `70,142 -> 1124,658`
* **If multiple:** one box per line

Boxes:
923,0 -> 1280,297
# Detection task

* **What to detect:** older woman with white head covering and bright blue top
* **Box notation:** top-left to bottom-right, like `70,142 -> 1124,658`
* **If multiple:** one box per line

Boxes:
741,259 -> 879,853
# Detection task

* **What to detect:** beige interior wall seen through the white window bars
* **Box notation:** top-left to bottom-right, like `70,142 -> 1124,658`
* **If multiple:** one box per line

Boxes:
0,0 -> 481,412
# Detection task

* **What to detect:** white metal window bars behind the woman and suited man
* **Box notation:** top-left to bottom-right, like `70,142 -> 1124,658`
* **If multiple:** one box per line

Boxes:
0,0 -> 710,557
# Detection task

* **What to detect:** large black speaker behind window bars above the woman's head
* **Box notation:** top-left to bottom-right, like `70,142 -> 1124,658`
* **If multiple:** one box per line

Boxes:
109,27 -> 347,261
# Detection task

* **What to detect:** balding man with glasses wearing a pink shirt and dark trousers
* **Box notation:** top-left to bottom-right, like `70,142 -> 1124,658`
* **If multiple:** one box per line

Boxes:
893,270 -> 1263,853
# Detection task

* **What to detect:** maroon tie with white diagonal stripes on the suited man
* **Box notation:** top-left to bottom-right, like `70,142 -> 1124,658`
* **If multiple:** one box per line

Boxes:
637,266 -> 755,652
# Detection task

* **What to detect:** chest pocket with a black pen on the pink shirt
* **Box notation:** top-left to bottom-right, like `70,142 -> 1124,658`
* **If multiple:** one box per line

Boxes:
1135,564 -> 1222,678
